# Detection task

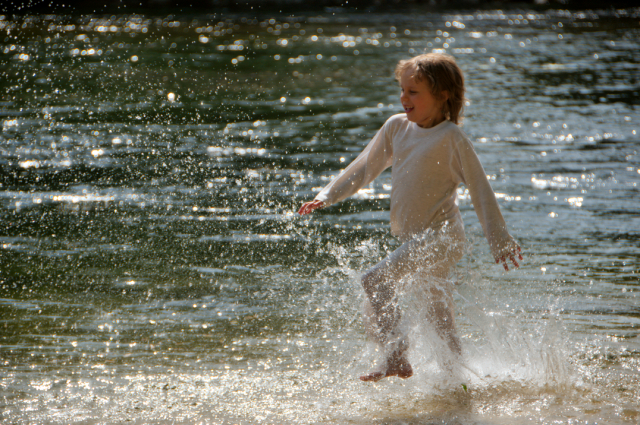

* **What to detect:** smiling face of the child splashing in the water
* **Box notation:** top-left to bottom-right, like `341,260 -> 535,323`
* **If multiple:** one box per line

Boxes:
400,68 -> 446,128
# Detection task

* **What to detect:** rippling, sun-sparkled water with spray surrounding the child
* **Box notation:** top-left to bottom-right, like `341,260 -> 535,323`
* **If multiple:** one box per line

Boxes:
0,9 -> 640,425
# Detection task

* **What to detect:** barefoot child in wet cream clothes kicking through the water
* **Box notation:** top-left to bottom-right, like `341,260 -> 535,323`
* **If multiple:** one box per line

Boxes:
298,53 -> 522,381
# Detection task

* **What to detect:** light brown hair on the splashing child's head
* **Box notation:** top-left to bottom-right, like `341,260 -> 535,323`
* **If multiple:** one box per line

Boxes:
395,53 -> 464,124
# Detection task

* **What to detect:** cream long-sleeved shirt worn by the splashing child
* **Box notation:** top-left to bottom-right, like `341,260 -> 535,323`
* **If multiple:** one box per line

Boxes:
315,114 -> 515,257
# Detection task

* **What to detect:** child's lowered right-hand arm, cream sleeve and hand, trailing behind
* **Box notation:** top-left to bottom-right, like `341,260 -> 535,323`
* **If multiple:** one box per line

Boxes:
452,139 -> 522,270
